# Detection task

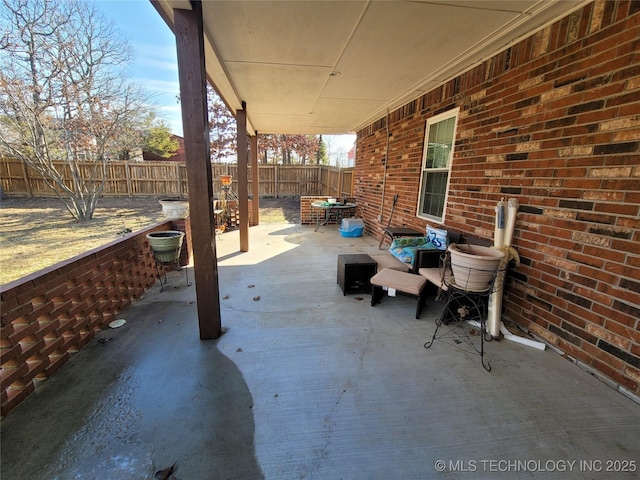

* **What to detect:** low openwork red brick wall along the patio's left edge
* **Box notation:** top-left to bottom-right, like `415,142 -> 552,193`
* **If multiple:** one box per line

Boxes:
0,221 -> 191,416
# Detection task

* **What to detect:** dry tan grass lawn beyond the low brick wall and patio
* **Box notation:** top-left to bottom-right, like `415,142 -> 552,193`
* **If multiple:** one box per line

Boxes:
0,197 -> 300,284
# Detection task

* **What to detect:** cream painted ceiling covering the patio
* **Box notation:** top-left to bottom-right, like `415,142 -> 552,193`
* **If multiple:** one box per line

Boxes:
151,0 -> 588,135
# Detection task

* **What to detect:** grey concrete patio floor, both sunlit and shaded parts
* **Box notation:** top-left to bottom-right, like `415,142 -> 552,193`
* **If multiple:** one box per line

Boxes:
1,224 -> 640,480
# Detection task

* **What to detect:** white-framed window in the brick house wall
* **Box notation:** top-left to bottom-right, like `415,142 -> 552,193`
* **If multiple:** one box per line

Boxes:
416,108 -> 460,223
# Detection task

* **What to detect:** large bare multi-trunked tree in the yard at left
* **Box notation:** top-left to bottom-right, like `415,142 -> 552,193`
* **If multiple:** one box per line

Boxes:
0,0 -> 152,221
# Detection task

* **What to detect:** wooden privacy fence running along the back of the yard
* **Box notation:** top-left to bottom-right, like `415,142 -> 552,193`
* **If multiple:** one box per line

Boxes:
0,158 -> 353,197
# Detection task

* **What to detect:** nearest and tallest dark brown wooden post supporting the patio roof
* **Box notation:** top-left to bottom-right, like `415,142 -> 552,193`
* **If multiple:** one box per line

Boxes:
173,2 -> 222,340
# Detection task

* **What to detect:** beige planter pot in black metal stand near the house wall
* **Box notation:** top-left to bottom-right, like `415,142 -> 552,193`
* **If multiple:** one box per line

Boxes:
449,244 -> 504,292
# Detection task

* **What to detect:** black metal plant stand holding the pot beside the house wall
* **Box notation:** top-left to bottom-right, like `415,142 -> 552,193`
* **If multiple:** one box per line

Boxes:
424,252 -> 504,372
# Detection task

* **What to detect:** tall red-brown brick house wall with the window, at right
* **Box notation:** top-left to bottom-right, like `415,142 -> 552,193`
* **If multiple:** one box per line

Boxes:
355,1 -> 640,395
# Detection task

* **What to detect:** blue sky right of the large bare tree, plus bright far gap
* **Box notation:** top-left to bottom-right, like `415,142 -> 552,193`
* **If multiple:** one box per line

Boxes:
94,0 -> 355,160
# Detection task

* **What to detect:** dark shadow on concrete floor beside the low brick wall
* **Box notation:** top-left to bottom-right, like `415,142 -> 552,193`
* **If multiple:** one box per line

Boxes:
2,296 -> 264,480
